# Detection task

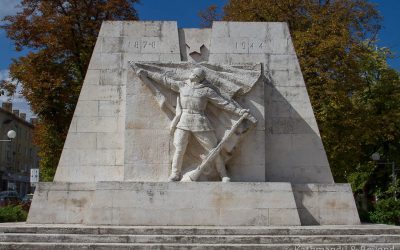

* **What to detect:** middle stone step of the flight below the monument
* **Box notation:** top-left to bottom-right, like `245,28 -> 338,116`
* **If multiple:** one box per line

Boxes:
0,233 -> 400,244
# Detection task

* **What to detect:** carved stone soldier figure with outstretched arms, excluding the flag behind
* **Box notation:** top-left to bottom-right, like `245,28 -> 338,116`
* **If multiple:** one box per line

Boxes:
134,63 -> 256,182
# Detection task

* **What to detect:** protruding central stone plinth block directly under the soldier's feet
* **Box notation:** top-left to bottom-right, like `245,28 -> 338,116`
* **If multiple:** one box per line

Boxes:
85,182 -> 300,226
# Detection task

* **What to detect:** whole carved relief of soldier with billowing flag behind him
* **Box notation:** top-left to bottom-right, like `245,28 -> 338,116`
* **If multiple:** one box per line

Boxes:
131,63 -> 261,182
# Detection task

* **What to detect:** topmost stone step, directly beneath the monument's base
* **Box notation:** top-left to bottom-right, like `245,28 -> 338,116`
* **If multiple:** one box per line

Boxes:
0,223 -> 400,235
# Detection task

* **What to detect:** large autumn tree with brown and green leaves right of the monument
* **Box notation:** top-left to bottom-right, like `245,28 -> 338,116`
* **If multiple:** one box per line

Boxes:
202,0 -> 400,182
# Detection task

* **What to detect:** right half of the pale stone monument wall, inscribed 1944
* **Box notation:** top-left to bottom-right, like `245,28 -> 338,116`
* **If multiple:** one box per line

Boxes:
209,22 -> 333,183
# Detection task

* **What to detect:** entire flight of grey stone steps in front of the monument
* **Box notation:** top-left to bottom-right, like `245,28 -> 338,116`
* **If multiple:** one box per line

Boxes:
0,223 -> 400,250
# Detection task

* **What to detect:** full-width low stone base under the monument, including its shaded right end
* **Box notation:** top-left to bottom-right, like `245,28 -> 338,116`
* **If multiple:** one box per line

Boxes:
28,182 -> 360,226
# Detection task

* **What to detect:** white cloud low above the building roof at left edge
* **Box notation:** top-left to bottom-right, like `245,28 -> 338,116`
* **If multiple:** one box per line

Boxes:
0,68 -> 34,120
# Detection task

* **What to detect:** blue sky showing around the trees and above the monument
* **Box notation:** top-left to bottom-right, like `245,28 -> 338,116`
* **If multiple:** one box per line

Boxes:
0,0 -> 400,117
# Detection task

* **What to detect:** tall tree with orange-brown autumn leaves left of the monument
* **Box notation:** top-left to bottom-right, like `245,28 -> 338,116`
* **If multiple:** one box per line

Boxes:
2,0 -> 138,181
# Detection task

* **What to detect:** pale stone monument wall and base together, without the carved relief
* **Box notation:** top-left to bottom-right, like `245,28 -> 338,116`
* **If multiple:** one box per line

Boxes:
29,21 -> 359,227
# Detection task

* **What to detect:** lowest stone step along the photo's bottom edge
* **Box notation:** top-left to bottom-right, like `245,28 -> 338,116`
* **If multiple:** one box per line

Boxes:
0,242 -> 400,250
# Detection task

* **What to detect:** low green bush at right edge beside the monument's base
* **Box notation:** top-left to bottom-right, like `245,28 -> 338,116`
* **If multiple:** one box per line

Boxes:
369,198 -> 400,225
